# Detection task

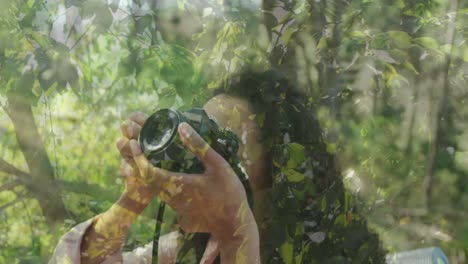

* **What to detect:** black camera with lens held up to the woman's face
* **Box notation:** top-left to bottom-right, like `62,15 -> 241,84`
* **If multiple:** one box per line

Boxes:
139,108 -> 250,187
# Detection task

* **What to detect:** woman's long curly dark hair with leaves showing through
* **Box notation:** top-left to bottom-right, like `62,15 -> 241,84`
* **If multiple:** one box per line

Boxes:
215,70 -> 385,263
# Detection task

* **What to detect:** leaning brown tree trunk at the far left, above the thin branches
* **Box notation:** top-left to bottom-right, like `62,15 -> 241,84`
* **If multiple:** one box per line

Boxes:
7,94 -> 67,226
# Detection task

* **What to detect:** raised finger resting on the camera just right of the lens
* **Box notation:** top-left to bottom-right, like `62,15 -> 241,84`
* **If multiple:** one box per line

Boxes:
178,122 -> 226,170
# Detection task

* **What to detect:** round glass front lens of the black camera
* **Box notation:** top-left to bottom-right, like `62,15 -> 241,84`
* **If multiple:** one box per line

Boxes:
140,109 -> 180,156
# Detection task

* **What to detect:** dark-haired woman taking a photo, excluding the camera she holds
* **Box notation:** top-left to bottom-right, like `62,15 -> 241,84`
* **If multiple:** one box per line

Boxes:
52,71 -> 384,263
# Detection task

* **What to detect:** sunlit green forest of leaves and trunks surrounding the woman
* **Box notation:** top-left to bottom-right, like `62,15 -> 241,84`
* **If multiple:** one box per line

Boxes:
0,0 -> 468,264
